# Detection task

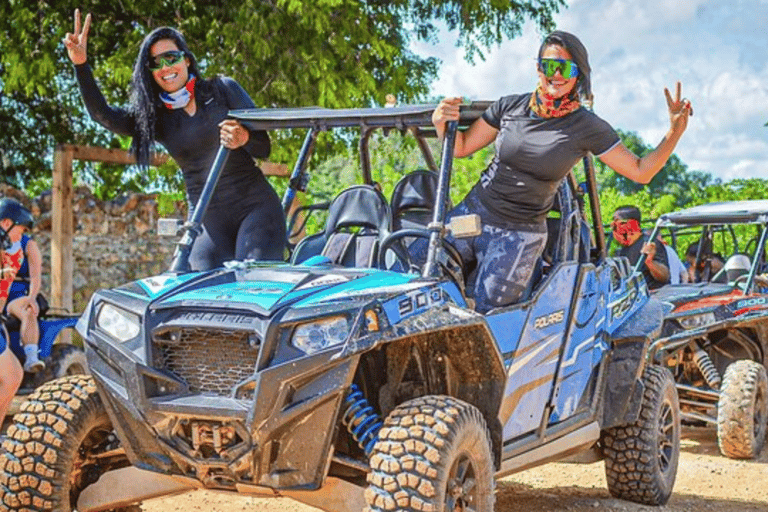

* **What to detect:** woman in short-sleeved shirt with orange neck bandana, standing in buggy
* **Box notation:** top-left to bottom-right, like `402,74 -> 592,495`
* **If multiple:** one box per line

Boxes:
432,31 -> 691,312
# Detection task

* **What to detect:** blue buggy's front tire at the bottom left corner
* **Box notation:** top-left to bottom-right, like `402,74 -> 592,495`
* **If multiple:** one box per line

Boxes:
0,375 -> 141,512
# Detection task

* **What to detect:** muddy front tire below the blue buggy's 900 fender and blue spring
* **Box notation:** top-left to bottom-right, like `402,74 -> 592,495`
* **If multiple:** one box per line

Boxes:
365,396 -> 494,512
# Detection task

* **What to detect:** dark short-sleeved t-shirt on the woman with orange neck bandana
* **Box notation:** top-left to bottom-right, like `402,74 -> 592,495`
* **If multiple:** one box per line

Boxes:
476,93 -> 620,231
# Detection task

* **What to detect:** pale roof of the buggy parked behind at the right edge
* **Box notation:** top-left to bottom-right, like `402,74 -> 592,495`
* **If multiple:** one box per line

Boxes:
658,199 -> 768,227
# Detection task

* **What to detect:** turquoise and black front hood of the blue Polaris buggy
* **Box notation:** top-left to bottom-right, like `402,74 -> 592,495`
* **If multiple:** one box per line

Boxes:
78,262 -> 465,355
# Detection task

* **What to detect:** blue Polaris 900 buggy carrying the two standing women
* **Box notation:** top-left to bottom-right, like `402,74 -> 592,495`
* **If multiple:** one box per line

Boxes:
0,103 -> 680,512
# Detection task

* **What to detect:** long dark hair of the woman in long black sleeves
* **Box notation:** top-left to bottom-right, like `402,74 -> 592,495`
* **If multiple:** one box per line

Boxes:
131,27 -> 201,168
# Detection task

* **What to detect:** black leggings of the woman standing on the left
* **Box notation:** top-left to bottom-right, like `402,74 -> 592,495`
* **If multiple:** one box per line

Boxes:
189,196 -> 286,270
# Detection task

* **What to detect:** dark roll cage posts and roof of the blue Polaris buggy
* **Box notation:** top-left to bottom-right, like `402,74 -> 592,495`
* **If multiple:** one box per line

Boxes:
169,101 -> 606,277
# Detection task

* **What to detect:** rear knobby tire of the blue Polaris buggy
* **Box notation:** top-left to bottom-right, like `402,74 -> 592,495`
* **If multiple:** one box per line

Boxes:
601,366 -> 680,505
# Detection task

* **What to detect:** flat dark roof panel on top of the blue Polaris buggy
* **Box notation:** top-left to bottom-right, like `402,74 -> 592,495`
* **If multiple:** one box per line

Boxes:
229,101 -> 491,130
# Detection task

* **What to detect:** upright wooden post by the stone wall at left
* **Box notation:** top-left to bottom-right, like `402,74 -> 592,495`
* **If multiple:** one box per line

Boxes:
51,146 -> 73,318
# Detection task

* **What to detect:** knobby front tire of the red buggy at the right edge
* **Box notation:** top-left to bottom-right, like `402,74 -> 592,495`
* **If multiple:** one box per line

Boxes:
717,359 -> 768,459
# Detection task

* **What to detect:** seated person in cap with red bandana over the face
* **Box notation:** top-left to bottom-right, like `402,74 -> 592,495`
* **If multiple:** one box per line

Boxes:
611,206 -> 670,290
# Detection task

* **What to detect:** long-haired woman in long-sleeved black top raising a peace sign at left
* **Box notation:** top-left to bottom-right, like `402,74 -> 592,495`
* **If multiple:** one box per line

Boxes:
64,10 -> 286,270
